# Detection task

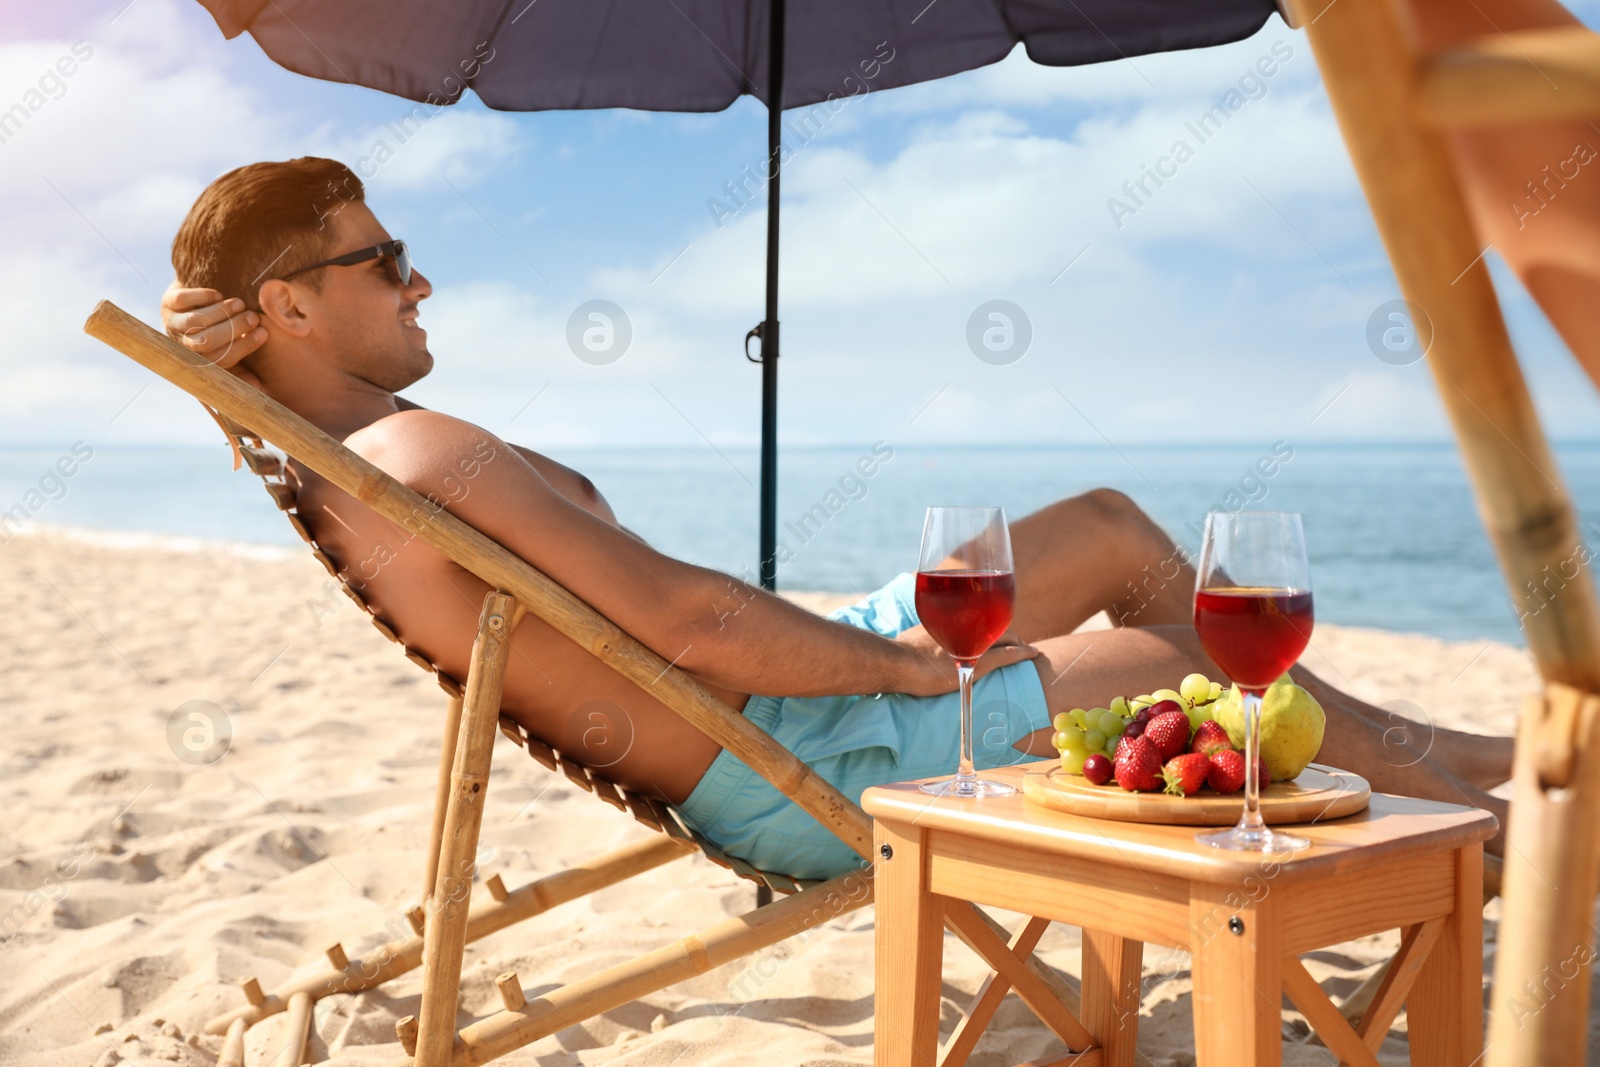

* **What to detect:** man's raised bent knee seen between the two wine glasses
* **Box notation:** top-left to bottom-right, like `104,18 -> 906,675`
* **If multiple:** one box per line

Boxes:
1011,490 -> 1195,639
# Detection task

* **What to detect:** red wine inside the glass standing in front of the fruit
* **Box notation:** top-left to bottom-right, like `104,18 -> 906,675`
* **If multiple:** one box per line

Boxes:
1195,589 -> 1312,689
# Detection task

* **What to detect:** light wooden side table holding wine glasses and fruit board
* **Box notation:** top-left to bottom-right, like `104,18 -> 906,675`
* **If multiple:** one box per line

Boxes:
862,765 -> 1494,1067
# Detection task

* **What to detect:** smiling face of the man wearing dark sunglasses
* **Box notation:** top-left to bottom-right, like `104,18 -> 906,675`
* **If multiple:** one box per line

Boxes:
290,203 -> 434,392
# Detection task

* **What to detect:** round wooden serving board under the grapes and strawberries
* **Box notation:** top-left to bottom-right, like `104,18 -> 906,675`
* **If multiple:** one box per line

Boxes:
1022,760 -> 1373,825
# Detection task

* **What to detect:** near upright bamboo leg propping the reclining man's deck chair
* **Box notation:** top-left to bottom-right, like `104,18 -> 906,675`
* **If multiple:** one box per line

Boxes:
416,592 -> 523,1067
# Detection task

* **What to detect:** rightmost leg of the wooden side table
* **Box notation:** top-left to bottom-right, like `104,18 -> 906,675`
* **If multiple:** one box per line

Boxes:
1406,845 -> 1483,1067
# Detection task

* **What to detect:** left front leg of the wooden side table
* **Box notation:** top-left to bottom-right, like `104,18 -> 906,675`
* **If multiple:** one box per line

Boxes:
872,819 -> 944,1067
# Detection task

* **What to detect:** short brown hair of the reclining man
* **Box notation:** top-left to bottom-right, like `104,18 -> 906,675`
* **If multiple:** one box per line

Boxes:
173,155 -> 365,310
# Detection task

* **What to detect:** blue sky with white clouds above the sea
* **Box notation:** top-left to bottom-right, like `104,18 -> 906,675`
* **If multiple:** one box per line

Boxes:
0,0 -> 1600,448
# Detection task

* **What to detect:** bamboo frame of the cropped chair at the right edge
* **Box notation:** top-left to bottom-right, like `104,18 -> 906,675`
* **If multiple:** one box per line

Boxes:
1280,0 -> 1600,1067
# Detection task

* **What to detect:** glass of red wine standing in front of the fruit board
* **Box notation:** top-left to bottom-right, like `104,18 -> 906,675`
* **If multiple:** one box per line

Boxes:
1195,512 -> 1312,853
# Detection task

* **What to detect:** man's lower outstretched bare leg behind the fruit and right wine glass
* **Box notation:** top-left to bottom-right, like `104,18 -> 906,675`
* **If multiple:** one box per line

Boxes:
1018,625 -> 1507,854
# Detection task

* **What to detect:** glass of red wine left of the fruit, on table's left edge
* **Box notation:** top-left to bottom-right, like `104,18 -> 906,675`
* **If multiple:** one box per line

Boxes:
917,507 -> 1016,797
